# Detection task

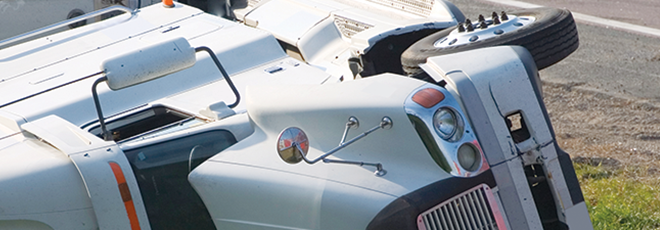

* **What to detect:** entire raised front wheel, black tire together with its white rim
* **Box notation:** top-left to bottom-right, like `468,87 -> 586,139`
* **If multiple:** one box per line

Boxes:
401,7 -> 579,76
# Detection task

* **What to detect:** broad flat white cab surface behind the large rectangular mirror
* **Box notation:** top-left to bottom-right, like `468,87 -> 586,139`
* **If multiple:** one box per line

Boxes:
0,4 -> 328,135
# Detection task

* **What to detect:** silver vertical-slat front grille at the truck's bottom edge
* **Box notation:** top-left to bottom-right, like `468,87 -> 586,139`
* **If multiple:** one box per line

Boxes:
417,184 -> 505,230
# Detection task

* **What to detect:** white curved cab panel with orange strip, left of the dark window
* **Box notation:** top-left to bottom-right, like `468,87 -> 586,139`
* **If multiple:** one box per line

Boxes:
21,115 -> 151,229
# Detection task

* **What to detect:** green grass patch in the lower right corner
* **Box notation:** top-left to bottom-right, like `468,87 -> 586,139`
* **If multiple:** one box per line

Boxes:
574,164 -> 660,230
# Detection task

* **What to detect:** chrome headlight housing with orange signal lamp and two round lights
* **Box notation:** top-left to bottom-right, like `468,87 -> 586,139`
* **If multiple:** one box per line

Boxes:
405,84 -> 490,177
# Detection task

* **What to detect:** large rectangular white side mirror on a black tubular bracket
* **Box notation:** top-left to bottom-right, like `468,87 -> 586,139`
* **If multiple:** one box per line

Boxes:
101,38 -> 197,90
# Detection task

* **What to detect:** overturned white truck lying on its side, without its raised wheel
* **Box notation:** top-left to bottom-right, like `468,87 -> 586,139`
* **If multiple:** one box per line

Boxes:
0,3 -> 592,229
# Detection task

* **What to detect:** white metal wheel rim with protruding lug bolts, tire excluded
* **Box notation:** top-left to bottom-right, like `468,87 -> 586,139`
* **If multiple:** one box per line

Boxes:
433,12 -> 536,48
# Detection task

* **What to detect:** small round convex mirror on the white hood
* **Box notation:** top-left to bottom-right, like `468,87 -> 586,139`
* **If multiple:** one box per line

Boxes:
277,127 -> 309,164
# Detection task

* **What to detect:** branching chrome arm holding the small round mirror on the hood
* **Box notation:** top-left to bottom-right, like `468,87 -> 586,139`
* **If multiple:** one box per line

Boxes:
292,117 -> 392,176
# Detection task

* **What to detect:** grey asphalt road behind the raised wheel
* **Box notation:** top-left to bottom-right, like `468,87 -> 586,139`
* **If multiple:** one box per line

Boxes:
450,0 -> 660,104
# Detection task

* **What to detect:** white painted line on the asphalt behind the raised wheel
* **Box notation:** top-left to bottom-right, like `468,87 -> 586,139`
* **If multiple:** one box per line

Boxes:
485,0 -> 660,37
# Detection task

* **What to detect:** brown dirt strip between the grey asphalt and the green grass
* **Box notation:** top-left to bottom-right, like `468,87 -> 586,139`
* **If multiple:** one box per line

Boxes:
543,81 -> 660,172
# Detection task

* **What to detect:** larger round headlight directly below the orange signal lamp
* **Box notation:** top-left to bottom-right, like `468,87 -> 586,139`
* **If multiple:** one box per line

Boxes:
433,107 -> 463,141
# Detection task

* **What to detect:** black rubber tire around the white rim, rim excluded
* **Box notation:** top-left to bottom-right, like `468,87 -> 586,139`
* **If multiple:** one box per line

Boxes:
401,8 -> 579,75
